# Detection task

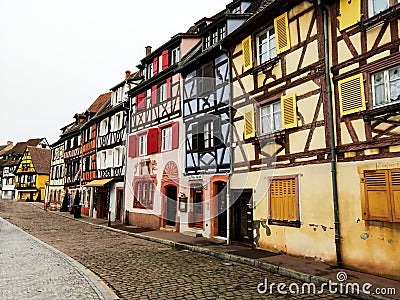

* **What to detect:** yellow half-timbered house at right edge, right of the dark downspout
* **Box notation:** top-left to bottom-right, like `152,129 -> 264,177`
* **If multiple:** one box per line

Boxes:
328,0 -> 400,277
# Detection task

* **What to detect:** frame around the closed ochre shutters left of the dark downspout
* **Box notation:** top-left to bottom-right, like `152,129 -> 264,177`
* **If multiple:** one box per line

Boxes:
267,175 -> 301,228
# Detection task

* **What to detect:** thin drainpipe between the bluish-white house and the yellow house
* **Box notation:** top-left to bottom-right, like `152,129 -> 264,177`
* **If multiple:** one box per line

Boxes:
220,45 -> 234,246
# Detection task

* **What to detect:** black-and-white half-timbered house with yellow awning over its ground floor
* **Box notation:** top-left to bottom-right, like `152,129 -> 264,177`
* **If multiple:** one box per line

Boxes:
86,71 -> 140,221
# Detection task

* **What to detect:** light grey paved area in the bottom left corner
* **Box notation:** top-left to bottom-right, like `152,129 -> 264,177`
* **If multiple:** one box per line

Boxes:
0,213 -> 112,300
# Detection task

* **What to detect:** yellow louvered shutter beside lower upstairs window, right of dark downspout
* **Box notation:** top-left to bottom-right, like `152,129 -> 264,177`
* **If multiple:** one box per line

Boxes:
338,74 -> 366,116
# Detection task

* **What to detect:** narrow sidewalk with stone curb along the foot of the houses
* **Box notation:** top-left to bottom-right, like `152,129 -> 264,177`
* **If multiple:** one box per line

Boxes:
45,205 -> 400,299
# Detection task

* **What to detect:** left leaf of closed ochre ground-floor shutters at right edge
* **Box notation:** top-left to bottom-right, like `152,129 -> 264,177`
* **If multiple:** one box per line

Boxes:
363,170 -> 391,221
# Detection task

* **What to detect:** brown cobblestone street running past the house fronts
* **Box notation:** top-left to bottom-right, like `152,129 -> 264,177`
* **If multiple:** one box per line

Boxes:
0,200 -> 348,299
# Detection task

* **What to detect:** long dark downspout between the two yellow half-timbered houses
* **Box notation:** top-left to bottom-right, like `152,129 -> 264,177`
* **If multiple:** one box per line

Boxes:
317,0 -> 343,267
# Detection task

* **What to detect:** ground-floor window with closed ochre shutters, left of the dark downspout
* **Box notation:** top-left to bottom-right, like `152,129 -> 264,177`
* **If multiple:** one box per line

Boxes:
269,176 -> 300,227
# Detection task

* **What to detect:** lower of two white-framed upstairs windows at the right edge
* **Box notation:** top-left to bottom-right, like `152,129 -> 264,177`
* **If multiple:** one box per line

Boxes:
372,66 -> 400,106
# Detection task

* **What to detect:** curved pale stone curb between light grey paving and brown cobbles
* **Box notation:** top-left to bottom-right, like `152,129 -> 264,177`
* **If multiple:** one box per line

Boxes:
2,218 -> 120,300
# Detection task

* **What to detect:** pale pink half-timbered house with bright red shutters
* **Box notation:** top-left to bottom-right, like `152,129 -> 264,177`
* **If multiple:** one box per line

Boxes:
125,30 -> 199,230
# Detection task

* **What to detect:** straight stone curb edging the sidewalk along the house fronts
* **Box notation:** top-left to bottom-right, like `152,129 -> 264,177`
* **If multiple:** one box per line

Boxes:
43,205 -> 392,300
